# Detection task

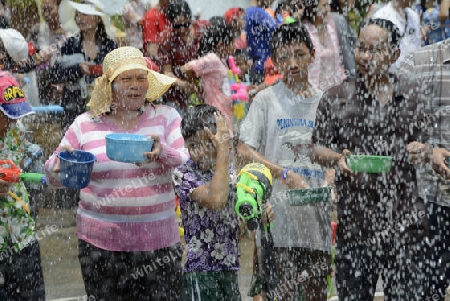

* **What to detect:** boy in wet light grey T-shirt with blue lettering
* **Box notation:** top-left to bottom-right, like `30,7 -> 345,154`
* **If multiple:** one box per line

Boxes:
237,22 -> 331,301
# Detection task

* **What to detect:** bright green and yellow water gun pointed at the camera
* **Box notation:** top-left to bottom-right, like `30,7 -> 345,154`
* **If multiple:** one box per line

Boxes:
234,163 -> 272,230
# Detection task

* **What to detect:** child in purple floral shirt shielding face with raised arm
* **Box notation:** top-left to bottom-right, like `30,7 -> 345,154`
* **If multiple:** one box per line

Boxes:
173,104 -> 241,300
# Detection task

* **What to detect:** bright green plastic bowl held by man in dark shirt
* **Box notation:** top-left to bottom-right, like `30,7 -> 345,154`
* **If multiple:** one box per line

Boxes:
347,155 -> 392,173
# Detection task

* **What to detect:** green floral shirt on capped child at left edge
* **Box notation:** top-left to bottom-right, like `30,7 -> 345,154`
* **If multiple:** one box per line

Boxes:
0,122 -> 35,252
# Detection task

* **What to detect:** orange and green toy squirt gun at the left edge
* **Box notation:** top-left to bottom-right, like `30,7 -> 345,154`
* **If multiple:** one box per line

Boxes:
0,160 -> 47,214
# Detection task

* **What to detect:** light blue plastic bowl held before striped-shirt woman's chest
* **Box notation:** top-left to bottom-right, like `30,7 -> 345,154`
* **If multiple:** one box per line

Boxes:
106,133 -> 153,163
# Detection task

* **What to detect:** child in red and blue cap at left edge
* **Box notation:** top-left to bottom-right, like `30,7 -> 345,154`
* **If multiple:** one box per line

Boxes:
0,71 -> 45,301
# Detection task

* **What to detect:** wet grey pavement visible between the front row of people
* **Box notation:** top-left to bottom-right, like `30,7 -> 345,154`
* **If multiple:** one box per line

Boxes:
37,208 -> 450,301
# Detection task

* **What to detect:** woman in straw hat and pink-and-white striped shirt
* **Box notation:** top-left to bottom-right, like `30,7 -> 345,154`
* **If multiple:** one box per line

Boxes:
45,47 -> 189,300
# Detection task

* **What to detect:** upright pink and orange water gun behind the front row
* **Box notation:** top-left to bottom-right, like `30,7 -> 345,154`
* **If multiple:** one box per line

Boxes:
228,56 -> 248,123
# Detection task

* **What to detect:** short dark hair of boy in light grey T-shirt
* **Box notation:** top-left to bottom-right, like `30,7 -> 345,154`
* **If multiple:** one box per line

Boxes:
270,21 -> 314,57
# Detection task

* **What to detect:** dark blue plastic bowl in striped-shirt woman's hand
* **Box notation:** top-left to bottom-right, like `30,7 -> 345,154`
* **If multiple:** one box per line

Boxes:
58,150 -> 95,189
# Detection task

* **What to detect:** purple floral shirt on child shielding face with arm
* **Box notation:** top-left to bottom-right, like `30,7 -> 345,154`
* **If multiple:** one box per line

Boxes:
173,160 -> 240,273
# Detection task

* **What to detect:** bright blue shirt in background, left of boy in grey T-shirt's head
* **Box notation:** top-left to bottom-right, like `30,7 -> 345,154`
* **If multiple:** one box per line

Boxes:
245,6 -> 279,74
